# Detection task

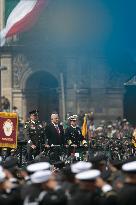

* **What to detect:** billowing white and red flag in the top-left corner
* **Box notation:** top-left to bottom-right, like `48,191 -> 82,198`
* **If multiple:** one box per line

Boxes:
0,0 -> 47,46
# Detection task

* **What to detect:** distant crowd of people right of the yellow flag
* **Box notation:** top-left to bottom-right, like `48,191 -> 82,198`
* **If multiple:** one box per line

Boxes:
89,119 -> 136,160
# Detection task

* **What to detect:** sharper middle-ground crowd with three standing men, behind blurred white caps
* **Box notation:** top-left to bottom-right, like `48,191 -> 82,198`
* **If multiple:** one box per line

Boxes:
1,110 -> 136,164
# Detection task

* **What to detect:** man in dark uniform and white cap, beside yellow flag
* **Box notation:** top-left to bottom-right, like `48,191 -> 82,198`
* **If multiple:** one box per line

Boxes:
65,115 -> 83,157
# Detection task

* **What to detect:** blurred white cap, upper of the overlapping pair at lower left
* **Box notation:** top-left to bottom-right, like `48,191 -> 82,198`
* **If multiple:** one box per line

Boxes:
26,162 -> 50,172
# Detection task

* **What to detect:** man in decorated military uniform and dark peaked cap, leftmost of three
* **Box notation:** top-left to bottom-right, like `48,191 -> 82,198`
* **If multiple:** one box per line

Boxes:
24,110 -> 46,161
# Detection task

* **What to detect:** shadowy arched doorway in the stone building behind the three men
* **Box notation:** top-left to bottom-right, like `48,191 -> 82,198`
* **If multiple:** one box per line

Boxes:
25,71 -> 59,121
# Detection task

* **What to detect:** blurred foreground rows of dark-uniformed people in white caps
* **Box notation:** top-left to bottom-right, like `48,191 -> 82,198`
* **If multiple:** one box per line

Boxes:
0,151 -> 136,205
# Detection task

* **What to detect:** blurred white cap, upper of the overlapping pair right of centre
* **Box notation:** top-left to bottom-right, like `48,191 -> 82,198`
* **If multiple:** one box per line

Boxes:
71,161 -> 92,174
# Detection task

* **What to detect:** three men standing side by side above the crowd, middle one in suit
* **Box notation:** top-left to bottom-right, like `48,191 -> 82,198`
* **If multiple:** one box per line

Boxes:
24,110 -> 84,161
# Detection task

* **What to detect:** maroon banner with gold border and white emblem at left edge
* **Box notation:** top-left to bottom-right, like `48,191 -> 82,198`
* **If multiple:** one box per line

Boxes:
0,112 -> 18,148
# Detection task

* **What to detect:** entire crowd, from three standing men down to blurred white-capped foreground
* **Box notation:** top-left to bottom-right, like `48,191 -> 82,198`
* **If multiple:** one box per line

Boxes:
0,110 -> 136,205
